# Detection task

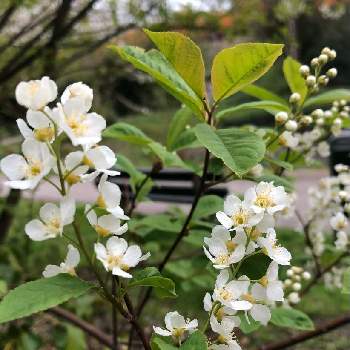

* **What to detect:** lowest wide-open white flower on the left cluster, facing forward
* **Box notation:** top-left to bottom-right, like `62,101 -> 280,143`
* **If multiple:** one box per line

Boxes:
95,236 -> 150,278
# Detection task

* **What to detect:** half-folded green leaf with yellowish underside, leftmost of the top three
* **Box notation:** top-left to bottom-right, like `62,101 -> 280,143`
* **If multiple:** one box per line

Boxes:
111,46 -> 203,119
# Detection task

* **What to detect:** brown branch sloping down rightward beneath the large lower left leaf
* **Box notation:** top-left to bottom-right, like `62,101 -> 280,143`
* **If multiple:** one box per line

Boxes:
48,307 -> 112,348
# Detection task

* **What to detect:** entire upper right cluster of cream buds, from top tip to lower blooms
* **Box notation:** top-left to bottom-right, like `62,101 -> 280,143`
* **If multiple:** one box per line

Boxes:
275,47 -> 349,162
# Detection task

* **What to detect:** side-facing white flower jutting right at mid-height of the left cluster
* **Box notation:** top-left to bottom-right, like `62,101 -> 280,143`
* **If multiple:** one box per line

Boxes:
70,146 -> 120,181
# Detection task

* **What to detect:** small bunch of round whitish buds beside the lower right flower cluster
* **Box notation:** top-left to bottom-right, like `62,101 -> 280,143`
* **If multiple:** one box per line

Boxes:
283,266 -> 311,305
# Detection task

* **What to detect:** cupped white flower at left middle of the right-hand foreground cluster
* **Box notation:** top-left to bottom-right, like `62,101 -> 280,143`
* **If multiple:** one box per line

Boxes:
203,226 -> 247,269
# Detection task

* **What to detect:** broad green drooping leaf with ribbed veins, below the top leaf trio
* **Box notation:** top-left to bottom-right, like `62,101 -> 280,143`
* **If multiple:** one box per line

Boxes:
195,124 -> 265,176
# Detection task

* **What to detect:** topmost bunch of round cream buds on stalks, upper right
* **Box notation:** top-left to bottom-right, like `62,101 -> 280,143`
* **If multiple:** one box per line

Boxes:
299,47 -> 338,94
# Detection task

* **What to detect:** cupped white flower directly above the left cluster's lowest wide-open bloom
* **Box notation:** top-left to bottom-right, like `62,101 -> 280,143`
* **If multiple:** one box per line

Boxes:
85,205 -> 128,237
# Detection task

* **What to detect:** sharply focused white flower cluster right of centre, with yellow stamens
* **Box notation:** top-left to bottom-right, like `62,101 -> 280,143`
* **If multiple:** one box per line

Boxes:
204,182 -> 291,350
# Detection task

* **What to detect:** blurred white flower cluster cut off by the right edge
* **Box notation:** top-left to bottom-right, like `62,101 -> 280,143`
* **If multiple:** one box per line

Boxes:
309,164 -> 350,256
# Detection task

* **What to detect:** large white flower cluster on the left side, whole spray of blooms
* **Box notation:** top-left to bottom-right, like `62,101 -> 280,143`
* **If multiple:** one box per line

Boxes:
0,77 -> 149,278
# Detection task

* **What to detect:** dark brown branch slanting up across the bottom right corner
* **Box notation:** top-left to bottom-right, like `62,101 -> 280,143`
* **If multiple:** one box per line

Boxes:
258,314 -> 350,350
